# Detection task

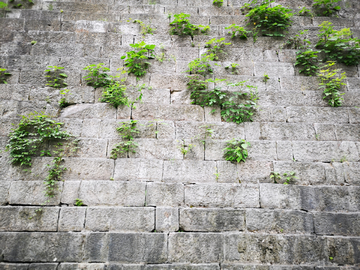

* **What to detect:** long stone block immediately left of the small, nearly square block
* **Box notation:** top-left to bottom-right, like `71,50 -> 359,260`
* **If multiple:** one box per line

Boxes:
85,207 -> 155,232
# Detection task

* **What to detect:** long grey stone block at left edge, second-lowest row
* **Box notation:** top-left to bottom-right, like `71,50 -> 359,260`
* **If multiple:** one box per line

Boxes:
0,232 -> 83,262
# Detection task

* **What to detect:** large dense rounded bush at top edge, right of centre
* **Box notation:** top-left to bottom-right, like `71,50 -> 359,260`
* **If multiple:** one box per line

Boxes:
242,0 -> 293,37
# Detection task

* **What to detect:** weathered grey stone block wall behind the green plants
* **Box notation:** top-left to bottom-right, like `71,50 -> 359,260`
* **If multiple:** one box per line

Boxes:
0,0 -> 360,270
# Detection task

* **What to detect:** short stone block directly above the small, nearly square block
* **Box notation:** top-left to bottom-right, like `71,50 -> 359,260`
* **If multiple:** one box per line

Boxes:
146,183 -> 184,207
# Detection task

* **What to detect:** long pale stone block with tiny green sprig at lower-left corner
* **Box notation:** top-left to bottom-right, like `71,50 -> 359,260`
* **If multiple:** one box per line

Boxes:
79,181 -> 145,206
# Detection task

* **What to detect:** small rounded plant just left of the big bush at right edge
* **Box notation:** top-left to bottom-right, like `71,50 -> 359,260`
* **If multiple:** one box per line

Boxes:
295,49 -> 320,76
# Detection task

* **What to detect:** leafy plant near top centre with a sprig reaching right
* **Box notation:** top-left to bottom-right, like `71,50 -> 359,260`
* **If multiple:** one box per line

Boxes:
170,13 -> 210,37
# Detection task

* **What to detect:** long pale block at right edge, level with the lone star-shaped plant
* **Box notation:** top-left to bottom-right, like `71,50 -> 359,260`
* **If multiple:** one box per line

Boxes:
293,141 -> 359,162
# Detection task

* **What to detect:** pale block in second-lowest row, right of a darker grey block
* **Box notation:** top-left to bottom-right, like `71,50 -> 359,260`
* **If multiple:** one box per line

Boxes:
169,233 -> 223,263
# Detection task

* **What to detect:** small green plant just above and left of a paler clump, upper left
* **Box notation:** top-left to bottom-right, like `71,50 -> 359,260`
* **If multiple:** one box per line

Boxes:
83,63 -> 112,88
